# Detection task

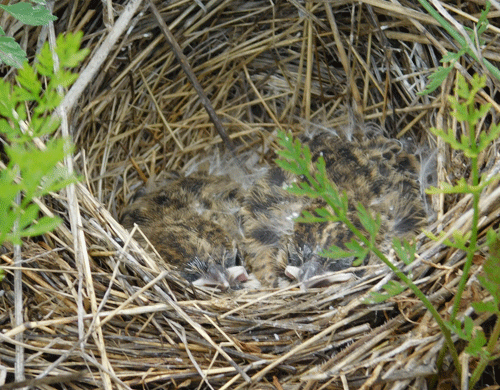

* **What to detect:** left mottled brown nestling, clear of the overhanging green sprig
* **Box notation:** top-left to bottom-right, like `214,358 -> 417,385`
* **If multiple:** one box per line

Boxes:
121,174 -> 248,290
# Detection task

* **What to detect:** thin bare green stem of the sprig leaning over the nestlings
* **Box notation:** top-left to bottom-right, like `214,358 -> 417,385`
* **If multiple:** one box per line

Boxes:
320,190 -> 462,377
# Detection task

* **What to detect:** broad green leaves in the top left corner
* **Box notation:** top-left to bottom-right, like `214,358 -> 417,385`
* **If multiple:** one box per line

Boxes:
0,0 -> 57,68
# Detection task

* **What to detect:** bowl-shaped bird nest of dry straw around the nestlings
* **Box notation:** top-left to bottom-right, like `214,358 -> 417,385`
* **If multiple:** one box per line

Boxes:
0,0 -> 500,389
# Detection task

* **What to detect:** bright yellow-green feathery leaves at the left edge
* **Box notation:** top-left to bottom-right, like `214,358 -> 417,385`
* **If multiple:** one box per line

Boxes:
0,33 -> 88,250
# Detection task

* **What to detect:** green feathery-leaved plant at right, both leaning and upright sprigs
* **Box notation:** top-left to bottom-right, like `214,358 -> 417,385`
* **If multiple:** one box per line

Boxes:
277,75 -> 500,388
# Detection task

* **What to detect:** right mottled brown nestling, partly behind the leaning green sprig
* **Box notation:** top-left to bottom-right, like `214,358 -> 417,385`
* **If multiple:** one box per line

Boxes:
242,129 -> 426,289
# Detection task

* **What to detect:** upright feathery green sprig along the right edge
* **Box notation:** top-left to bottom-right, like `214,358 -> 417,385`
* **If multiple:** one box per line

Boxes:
426,75 -> 500,388
